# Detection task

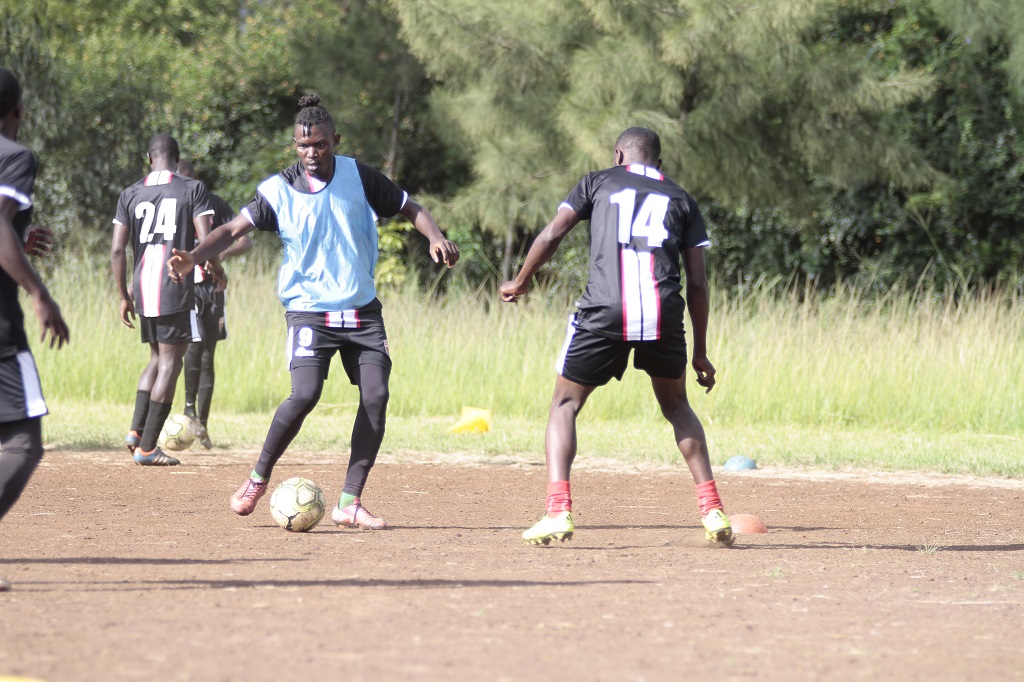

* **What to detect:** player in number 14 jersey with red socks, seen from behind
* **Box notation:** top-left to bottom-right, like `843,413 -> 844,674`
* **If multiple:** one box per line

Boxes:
501,128 -> 733,545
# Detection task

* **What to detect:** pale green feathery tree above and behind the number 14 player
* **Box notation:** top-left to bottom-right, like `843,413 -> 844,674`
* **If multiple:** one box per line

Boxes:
395,0 -> 941,286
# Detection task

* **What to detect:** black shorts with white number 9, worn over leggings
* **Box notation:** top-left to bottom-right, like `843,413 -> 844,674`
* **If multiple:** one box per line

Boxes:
285,310 -> 391,385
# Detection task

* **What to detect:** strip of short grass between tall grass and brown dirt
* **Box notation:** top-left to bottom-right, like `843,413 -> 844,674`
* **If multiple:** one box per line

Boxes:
43,390 -> 1024,477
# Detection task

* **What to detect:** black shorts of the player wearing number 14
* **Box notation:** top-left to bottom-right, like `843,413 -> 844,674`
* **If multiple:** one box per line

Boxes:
555,314 -> 686,386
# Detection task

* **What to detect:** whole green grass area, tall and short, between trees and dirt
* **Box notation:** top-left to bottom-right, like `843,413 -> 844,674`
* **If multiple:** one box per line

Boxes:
25,261 -> 1024,476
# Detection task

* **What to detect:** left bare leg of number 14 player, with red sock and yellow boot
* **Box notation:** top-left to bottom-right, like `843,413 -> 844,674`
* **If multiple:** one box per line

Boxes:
522,376 -> 596,545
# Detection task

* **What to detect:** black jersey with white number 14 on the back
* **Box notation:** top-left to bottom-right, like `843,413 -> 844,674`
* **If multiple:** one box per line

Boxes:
563,164 -> 710,341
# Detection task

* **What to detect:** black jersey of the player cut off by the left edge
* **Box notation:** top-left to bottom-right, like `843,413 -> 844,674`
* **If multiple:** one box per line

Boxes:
0,135 -> 36,357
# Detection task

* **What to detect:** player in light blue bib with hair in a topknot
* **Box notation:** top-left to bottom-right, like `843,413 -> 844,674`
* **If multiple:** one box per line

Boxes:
168,94 -> 459,529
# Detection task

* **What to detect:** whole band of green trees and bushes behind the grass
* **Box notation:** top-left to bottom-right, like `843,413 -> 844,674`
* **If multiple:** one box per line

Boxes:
0,0 -> 1024,289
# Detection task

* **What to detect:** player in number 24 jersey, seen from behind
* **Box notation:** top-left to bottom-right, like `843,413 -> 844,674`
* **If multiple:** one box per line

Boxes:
111,134 -> 215,466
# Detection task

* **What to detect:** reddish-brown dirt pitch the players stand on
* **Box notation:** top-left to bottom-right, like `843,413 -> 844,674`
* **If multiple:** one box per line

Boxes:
0,451 -> 1024,682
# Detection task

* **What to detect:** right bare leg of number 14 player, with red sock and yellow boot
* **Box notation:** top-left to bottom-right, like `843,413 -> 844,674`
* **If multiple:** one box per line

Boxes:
650,373 -> 734,546
